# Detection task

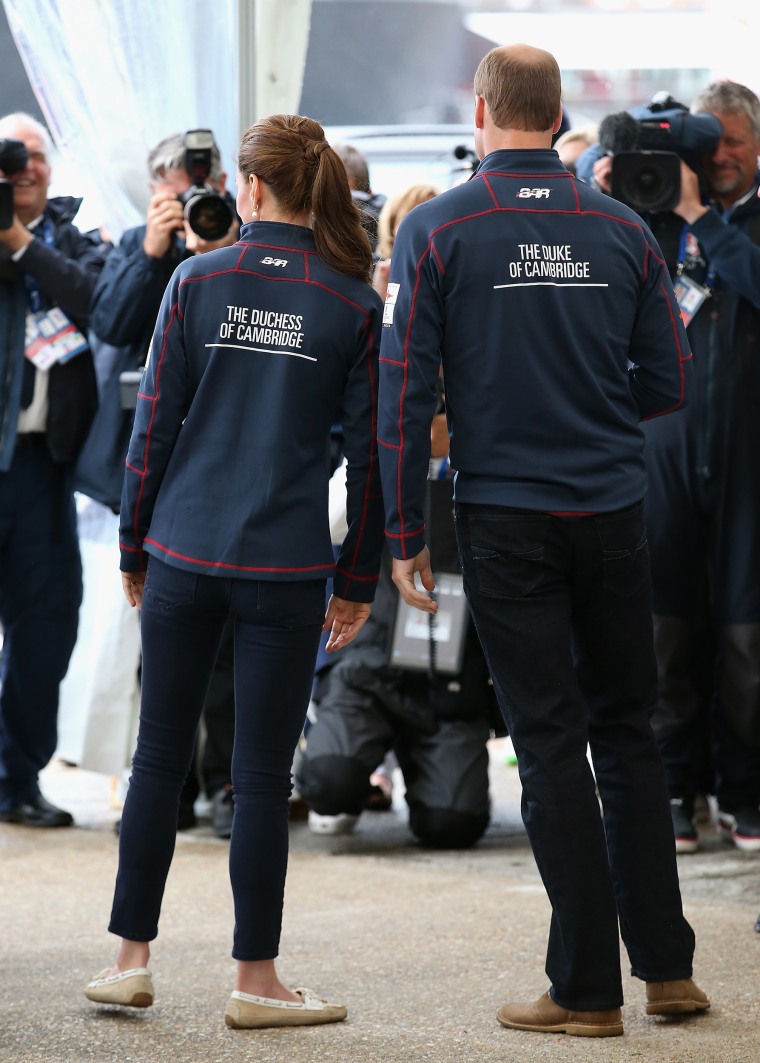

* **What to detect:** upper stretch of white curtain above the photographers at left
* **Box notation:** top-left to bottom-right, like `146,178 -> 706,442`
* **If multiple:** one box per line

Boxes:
3,0 -> 311,239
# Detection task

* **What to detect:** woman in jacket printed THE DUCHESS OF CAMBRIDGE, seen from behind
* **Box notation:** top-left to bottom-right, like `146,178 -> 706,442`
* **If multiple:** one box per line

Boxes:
85,115 -> 383,1027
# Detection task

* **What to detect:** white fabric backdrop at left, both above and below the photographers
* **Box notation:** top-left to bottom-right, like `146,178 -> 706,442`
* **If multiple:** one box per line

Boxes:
0,0 -> 311,775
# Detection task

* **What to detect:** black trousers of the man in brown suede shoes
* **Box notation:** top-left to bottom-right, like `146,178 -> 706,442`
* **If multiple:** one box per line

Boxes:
456,505 -> 694,1011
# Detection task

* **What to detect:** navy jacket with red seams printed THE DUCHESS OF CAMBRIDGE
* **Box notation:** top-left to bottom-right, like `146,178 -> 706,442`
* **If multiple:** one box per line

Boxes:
120,222 -> 383,602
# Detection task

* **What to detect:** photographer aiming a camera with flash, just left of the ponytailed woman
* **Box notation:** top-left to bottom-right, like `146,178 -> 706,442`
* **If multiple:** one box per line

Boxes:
77,131 -> 239,838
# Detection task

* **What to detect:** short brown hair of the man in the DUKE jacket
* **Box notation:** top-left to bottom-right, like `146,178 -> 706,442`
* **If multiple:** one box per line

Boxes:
473,45 -> 562,133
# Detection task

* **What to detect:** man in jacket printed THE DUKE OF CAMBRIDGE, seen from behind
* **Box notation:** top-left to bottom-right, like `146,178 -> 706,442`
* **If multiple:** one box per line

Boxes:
377,45 -> 709,1036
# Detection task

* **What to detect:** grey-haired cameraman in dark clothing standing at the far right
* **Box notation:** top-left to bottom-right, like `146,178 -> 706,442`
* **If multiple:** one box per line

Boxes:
593,81 -> 760,853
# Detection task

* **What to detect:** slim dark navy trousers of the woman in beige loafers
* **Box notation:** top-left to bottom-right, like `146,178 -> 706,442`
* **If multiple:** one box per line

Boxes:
108,558 -> 324,960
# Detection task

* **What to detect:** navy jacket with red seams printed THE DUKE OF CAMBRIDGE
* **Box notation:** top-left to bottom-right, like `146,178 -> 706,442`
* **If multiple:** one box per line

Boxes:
378,155 -> 691,558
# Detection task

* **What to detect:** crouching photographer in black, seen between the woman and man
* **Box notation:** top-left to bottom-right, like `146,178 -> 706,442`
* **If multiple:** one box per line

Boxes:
295,403 -> 505,848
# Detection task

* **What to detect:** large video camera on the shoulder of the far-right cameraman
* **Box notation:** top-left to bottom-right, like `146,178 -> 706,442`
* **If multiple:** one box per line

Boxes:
598,92 -> 723,214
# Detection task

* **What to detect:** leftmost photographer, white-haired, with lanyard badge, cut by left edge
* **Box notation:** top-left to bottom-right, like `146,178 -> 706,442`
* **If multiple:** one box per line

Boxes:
0,114 -> 103,827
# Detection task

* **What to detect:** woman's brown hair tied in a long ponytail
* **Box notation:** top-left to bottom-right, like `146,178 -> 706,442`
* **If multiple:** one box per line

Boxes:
238,115 -> 372,281
